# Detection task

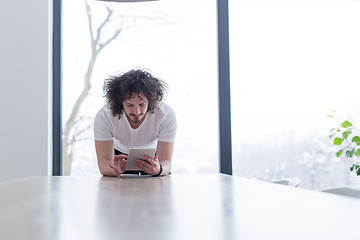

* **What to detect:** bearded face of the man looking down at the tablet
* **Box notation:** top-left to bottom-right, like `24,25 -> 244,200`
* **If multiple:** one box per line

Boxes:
123,93 -> 149,123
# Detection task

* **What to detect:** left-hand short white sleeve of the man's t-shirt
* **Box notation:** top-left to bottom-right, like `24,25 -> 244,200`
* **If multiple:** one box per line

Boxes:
94,108 -> 113,141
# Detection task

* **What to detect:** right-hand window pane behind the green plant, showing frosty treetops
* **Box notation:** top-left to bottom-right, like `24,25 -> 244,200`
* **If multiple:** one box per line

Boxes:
229,0 -> 360,189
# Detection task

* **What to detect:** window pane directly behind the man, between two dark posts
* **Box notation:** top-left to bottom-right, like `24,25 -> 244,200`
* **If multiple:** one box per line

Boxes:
62,0 -> 219,175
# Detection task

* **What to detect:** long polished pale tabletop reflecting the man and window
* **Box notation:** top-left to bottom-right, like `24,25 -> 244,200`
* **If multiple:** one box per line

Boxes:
0,174 -> 360,240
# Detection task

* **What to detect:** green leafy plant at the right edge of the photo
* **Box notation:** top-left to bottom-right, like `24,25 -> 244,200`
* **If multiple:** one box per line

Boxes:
328,115 -> 360,176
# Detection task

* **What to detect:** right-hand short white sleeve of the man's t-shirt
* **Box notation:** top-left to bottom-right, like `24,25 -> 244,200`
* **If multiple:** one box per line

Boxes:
158,108 -> 177,142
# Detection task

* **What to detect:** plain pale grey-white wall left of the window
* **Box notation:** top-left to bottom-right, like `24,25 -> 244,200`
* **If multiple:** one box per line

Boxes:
0,0 -> 52,180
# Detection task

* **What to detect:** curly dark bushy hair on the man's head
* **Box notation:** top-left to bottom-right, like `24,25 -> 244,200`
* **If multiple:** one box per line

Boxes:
103,69 -> 167,118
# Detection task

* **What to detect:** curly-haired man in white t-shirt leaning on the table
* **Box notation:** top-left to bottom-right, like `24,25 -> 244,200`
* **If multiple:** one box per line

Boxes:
94,69 -> 177,176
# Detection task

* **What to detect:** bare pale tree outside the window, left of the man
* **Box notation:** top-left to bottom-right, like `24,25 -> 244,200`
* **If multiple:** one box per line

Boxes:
62,0 -> 179,175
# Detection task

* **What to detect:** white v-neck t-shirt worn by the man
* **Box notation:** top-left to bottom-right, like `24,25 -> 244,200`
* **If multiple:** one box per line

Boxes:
94,102 -> 177,154
